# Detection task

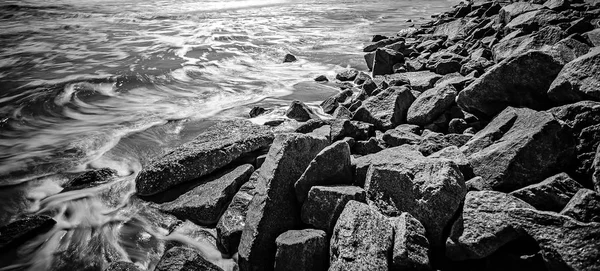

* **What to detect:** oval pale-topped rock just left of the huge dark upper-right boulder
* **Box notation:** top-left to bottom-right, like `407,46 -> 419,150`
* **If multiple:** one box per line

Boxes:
406,85 -> 458,126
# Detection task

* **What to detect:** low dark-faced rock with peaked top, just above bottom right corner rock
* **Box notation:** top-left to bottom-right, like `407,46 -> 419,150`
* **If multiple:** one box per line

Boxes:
510,173 -> 583,212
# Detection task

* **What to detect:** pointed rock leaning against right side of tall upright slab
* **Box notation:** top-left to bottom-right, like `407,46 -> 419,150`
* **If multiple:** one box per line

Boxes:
294,141 -> 353,203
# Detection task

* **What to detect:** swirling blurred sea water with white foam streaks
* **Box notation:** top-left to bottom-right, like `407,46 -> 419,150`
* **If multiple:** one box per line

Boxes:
0,0 -> 458,270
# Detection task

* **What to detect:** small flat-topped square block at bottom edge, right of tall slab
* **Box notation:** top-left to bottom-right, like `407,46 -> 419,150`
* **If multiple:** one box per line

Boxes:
275,229 -> 328,271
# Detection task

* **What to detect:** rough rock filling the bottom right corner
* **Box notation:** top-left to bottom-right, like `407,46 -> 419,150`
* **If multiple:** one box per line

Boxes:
509,208 -> 600,271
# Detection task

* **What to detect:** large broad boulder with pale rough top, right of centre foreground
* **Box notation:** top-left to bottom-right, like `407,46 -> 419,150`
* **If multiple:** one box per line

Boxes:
364,153 -> 467,247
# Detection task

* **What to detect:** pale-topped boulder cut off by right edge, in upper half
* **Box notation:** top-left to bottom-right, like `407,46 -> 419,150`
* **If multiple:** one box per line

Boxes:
548,48 -> 600,104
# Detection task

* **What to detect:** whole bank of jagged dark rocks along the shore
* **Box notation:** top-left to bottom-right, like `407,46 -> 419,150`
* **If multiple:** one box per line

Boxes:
0,0 -> 600,271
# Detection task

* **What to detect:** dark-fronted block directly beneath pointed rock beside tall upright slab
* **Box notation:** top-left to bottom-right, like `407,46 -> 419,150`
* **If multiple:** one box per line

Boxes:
302,185 -> 366,234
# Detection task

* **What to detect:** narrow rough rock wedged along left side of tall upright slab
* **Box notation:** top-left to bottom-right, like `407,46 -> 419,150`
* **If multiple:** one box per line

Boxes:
217,171 -> 262,255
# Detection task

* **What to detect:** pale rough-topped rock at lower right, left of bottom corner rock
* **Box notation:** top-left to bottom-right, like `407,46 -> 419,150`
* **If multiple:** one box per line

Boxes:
446,191 -> 533,261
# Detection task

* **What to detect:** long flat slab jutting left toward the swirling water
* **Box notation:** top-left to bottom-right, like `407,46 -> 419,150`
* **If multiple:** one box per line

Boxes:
135,120 -> 274,196
